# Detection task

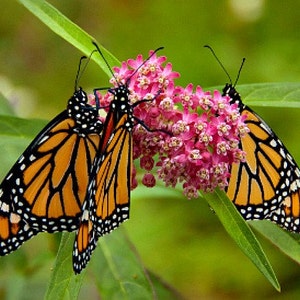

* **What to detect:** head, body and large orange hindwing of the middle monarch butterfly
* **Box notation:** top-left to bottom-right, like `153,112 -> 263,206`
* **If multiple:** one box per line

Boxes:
88,85 -> 134,236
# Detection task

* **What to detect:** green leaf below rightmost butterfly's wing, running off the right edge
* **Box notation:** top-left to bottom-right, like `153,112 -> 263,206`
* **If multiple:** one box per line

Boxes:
249,220 -> 300,264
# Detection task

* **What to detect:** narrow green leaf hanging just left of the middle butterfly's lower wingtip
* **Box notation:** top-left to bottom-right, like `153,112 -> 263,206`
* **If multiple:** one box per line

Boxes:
45,233 -> 85,300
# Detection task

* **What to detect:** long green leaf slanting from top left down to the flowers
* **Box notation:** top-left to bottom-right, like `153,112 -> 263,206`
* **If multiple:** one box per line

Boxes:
18,0 -> 120,77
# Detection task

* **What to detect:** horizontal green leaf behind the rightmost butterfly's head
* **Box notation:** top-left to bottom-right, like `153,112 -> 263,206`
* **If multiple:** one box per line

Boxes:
207,82 -> 300,108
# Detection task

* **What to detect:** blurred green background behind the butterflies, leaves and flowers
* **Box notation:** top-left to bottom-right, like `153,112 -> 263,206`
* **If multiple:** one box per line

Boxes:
0,0 -> 300,299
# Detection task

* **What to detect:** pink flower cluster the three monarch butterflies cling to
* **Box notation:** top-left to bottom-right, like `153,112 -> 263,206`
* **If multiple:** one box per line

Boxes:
93,52 -> 249,199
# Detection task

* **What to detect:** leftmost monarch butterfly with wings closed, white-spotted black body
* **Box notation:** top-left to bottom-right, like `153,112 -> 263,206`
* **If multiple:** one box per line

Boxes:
0,57 -> 102,255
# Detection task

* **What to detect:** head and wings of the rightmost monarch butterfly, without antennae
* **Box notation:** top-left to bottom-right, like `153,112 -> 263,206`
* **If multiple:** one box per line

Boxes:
223,85 -> 300,232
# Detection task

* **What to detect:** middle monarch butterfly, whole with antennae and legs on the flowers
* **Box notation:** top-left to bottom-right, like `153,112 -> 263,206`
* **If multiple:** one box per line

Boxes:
73,43 -> 162,274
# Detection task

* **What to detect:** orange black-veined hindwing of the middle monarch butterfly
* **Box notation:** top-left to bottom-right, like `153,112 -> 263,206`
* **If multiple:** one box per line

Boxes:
91,115 -> 132,236
